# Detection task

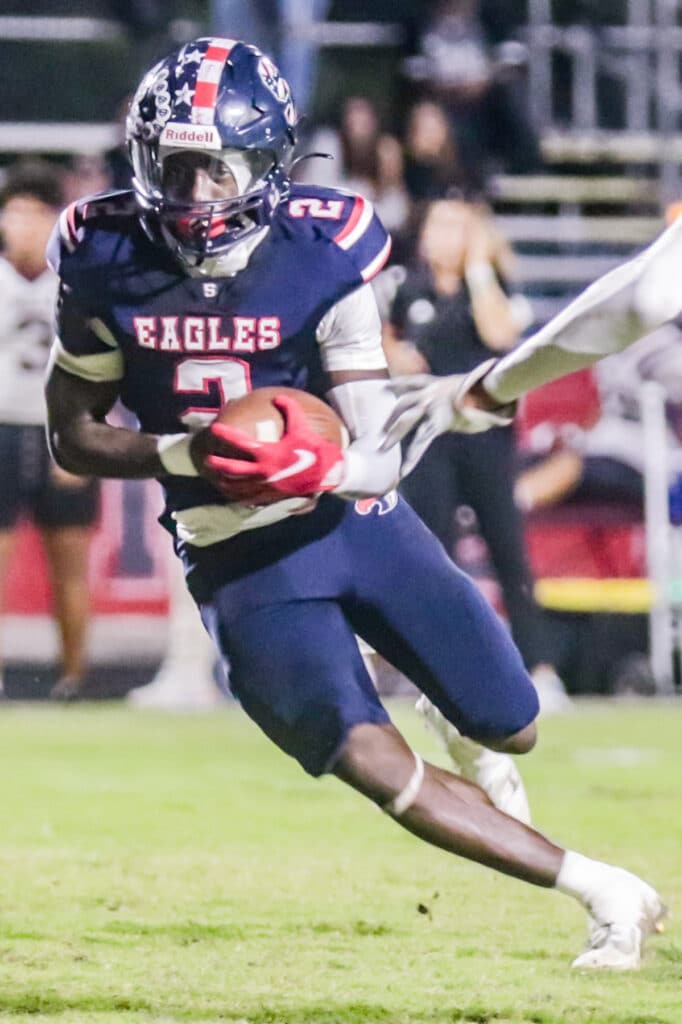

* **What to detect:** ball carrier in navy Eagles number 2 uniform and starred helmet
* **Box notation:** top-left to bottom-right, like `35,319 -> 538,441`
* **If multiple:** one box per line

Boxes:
47,38 -> 664,968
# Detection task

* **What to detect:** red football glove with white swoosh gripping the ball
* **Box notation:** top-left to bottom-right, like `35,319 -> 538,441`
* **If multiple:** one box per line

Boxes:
206,395 -> 344,504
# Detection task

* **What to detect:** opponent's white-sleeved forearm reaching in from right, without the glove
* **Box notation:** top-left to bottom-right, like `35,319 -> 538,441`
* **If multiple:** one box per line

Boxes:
483,216 -> 682,403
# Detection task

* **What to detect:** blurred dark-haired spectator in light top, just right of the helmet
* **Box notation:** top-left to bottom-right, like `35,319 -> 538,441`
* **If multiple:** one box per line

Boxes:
297,96 -> 410,233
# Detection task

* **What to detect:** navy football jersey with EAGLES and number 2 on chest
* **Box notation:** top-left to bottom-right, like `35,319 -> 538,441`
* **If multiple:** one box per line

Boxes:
50,185 -> 390,540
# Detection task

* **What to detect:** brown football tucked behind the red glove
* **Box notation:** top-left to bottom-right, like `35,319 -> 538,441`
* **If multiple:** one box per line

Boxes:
217,387 -> 348,446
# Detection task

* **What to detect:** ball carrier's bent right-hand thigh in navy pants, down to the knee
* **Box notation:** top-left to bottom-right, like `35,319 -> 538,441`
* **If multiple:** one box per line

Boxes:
344,495 -> 538,754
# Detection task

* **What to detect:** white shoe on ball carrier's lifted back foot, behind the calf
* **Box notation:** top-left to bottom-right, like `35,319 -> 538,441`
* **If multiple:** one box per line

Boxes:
417,696 -> 530,825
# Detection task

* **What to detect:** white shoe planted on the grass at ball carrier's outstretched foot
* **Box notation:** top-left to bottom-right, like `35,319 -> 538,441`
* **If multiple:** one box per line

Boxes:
571,867 -> 668,971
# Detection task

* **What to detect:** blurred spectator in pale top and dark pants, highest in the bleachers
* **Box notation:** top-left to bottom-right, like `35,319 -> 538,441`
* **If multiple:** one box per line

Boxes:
406,0 -> 542,188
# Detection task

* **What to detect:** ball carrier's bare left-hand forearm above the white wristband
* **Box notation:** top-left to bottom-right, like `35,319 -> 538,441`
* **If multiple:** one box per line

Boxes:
49,417 -> 166,479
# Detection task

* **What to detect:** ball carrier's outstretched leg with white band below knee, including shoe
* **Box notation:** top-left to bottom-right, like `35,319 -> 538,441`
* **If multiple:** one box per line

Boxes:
202,587 -> 663,967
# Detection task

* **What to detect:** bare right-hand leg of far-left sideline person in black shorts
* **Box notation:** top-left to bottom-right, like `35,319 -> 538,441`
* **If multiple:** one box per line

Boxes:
34,458 -> 99,700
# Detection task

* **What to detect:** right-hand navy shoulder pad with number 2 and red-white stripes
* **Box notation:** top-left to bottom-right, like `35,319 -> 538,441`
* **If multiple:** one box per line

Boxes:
287,185 -> 391,281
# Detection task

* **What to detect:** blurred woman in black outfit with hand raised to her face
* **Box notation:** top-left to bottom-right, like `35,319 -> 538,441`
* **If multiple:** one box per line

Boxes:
385,200 -> 567,711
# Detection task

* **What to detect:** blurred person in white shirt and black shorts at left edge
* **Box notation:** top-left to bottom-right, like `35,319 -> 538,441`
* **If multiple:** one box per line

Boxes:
0,162 -> 98,699
